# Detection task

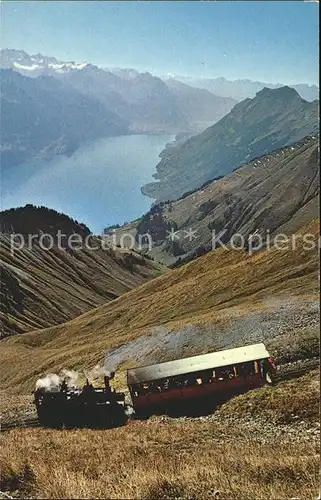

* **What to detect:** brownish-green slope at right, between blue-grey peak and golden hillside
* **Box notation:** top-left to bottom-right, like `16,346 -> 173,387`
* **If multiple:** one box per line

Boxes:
112,133 -> 320,265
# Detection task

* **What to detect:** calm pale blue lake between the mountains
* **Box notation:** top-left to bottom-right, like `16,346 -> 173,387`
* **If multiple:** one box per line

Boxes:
1,135 -> 174,233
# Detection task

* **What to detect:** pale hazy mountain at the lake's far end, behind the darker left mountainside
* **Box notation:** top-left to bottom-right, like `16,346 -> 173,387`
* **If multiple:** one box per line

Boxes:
61,64 -> 236,133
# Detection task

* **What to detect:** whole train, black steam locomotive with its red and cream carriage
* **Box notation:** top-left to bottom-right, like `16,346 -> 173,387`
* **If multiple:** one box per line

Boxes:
35,343 -> 276,427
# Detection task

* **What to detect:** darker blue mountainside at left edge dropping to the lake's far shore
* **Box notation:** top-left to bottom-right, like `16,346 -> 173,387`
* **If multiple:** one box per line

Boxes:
1,69 -> 127,168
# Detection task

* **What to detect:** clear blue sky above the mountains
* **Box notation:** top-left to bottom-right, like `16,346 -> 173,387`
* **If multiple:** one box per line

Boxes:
2,1 -> 318,84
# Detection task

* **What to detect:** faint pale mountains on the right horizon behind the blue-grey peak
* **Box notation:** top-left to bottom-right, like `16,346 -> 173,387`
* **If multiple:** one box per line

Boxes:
172,76 -> 319,101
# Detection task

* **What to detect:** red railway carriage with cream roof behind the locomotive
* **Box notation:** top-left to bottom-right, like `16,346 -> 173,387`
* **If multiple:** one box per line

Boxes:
127,343 -> 275,416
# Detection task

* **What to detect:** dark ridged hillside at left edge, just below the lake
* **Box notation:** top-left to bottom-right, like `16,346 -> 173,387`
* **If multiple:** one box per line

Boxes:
0,205 -> 162,335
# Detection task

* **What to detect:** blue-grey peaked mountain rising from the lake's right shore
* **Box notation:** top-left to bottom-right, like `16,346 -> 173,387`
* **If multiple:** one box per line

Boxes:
142,87 -> 319,200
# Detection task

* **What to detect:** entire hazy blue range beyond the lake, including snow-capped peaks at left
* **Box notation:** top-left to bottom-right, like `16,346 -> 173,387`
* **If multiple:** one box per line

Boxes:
0,49 -> 236,167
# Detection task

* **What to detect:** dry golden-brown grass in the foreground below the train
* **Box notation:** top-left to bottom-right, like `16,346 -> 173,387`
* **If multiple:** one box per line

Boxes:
0,421 -> 319,500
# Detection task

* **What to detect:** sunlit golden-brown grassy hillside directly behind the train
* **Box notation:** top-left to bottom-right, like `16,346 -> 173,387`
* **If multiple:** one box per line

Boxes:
0,222 -> 319,390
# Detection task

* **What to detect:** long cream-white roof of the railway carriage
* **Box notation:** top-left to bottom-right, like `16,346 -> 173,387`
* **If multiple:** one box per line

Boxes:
127,343 -> 270,385
